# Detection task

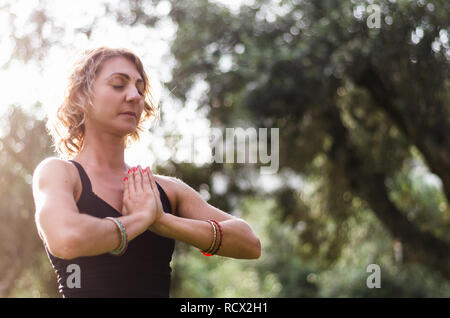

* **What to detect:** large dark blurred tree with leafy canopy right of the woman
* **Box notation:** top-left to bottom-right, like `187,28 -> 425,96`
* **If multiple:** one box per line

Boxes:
110,0 -> 450,279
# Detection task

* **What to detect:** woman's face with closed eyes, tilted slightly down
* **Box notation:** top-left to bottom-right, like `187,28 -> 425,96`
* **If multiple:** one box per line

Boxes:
87,57 -> 145,137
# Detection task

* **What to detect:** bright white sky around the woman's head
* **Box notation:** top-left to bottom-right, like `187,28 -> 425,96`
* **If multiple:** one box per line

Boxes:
0,0 -> 209,165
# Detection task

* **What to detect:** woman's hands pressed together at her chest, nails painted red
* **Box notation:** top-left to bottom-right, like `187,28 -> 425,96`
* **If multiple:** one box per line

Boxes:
122,165 -> 164,227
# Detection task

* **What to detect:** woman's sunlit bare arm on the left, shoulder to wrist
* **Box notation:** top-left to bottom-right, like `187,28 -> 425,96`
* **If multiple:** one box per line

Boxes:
33,158 -> 150,259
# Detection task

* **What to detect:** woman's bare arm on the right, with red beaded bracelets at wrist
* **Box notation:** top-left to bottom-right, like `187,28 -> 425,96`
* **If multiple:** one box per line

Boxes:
150,171 -> 261,259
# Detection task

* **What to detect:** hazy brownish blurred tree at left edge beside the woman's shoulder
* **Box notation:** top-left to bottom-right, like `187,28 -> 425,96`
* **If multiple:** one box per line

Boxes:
0,103 -> 56,297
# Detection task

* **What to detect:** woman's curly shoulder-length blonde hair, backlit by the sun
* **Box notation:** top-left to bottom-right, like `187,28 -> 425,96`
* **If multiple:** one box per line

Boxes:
46,46 -> 159,159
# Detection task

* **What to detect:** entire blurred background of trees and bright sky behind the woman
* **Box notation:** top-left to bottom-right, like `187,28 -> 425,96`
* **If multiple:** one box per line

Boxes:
0,0 -> 450,297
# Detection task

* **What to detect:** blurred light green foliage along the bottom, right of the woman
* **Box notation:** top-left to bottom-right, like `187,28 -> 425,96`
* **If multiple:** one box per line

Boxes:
171,186 -> 450,298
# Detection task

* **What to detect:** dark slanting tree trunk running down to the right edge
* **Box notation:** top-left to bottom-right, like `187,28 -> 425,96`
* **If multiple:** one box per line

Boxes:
327,103 -> 450,280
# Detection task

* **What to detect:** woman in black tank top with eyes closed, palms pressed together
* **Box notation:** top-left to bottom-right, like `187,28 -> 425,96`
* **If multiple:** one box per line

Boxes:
33,47 -> 260,297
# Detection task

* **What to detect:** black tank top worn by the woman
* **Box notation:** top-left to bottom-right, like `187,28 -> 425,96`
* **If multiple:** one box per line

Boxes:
46,160 -> 175,298
